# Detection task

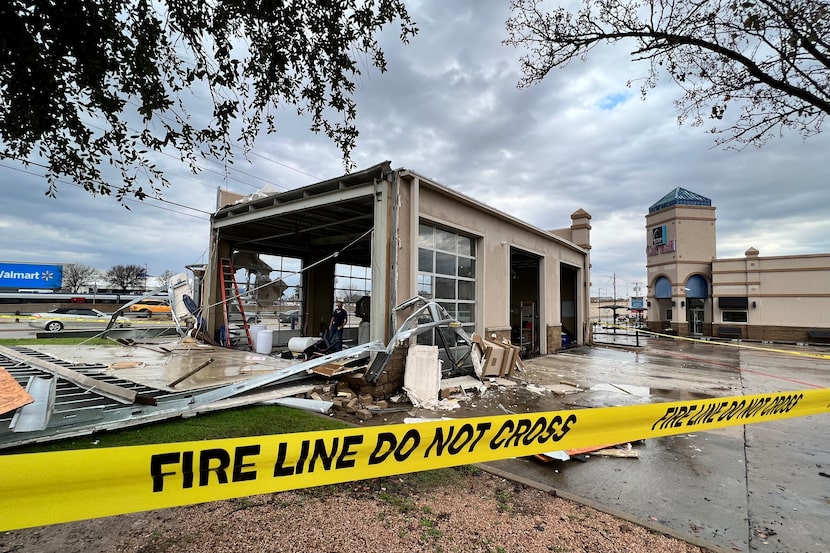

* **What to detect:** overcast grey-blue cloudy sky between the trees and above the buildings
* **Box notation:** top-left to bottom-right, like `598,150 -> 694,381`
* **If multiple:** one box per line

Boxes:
0,0 -> 830,295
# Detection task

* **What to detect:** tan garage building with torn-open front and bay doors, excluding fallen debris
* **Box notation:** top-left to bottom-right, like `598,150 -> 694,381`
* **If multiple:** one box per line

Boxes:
202,161 -> 591,395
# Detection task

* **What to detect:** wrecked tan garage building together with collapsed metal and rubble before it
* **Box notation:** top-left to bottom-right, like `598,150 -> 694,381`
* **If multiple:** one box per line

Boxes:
0,158 -> 591,448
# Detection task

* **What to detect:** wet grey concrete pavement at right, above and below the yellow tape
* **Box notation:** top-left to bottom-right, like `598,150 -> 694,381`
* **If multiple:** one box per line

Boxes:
488,336 -> 830,553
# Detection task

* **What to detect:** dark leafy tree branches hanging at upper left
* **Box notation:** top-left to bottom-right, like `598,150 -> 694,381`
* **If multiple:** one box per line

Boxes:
0,0 -> 417,201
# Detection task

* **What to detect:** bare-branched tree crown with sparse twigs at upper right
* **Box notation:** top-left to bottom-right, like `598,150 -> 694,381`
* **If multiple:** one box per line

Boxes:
506,0 -> 830,146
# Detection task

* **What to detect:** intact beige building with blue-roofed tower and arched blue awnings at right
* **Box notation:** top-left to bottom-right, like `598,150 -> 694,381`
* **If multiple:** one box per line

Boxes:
646,187 -> 830,343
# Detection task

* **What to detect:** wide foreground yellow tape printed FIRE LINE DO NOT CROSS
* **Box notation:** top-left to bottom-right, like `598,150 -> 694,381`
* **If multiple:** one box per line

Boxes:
0,388 -> 830,531
